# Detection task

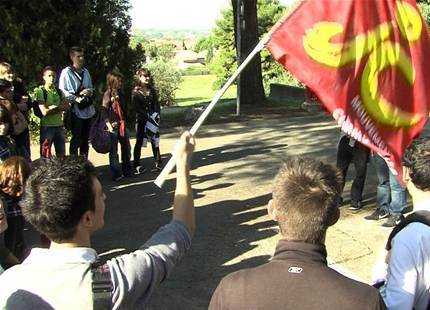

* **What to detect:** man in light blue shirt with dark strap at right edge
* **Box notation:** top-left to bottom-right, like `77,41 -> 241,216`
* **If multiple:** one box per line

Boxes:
373,137 -> 430,310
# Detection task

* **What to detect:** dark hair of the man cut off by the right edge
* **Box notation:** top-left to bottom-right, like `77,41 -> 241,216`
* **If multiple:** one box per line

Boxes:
402,137 -> 430,191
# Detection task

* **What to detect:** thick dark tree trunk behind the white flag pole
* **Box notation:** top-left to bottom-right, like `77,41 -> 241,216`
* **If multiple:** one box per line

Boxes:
232,0 -> 265,104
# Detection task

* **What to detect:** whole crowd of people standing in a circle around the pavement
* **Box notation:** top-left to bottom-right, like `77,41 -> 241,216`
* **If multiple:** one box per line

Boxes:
0,47 -> 430,309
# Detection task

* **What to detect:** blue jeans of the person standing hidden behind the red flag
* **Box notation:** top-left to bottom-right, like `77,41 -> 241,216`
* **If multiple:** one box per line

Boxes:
373,154 -> 407,215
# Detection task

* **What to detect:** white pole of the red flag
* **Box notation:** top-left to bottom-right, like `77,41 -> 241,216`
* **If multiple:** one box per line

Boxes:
154,34 -> 270,188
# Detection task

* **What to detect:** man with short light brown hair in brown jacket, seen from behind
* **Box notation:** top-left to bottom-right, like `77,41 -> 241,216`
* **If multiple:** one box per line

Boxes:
209,158 -> 385,310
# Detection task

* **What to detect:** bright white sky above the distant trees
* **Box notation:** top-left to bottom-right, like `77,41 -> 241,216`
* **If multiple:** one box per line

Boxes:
130,0 -> 291,30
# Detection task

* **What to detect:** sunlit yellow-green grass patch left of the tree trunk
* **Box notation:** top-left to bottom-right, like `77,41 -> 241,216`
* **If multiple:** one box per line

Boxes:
175,75 -> 236,106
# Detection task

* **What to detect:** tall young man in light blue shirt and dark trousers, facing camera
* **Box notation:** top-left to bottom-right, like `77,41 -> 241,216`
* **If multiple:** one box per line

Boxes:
58,46 -> 96,157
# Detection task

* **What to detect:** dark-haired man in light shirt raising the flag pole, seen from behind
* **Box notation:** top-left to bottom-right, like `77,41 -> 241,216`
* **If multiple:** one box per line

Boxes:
0,133 -> 195,309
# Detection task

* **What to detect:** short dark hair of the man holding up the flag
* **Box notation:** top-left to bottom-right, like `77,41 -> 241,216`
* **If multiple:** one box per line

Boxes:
21,156 -> 96,243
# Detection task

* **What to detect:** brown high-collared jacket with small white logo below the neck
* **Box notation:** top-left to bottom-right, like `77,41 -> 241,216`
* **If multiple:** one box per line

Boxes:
209,240 -> 386,310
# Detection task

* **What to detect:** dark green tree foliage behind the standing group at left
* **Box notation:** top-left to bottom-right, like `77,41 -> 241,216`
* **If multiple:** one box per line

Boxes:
0,0 -> 139,104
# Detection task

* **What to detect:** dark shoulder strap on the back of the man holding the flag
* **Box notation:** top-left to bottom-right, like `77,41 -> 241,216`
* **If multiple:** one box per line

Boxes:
91,260 -> 113,310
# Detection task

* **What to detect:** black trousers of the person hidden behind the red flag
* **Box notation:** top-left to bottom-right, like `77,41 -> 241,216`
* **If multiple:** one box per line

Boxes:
336,136 -> 370,202
